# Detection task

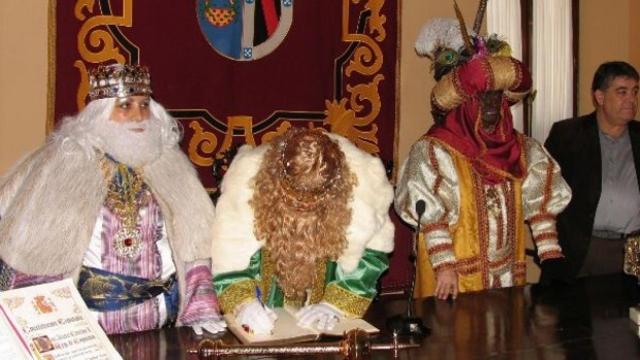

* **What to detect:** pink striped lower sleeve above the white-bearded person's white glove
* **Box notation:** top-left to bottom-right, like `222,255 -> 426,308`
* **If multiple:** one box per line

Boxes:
179,260 -> 220,325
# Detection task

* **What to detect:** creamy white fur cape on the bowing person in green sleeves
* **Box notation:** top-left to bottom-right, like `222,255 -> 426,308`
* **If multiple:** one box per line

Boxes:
211,134 -> 394,274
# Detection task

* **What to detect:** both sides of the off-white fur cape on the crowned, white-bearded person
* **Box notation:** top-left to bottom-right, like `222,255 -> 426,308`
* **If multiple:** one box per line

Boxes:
0,137 -> 214,276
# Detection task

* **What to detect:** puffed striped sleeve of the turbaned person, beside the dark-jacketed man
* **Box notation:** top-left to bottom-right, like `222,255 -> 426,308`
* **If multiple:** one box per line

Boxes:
522,139 -> 571,261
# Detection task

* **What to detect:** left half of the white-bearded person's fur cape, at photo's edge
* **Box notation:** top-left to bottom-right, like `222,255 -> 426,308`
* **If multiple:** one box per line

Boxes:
0,142 -> 106,275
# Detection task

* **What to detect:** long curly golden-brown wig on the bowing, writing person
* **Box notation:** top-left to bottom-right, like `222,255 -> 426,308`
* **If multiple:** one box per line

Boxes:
250,128 -> 356,300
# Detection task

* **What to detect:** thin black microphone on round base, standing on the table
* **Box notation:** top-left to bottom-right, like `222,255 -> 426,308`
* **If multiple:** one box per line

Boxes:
387,200 -> 431,339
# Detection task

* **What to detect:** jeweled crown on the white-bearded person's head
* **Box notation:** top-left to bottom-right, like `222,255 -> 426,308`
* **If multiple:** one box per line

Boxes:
89,64 -> 152,101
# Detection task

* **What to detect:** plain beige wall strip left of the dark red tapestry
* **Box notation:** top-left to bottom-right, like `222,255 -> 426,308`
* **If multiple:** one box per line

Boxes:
0,0 -> 47,174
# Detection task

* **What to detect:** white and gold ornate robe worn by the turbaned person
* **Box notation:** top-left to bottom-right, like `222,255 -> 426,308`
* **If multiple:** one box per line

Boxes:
395,135 -> 571,297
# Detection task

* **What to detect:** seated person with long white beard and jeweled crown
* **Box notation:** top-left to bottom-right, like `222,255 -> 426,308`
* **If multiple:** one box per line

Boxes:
0,64 -> 225,334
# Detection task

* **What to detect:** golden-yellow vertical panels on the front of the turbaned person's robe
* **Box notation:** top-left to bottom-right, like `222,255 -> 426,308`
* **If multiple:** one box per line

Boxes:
414,152 -> 525,298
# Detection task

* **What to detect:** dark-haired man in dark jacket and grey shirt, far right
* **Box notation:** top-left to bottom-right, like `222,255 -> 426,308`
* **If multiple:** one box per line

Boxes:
540,61 -> 640,283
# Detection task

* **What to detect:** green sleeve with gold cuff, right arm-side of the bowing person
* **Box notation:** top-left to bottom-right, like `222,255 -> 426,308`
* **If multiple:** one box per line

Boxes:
322,249 -> 389,318
